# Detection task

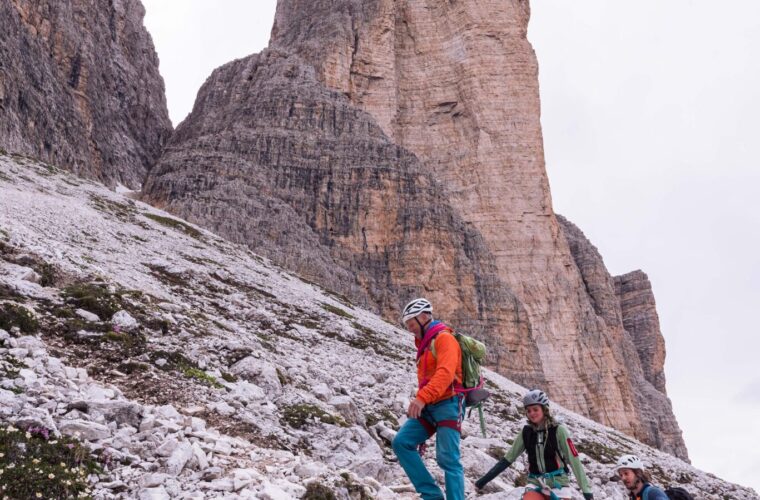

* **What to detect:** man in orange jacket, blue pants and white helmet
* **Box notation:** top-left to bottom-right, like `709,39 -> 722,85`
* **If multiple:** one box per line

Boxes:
393,298 -> 464,500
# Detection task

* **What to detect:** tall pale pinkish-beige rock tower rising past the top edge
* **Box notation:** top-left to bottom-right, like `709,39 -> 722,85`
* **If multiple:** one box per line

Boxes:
270,0 -> 685,453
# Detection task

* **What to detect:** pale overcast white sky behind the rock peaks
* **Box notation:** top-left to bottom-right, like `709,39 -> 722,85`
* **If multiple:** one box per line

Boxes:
143,0 -> 760,491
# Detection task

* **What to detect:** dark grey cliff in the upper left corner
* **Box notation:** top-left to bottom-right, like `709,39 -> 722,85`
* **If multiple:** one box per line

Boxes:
0,0 -> 172,188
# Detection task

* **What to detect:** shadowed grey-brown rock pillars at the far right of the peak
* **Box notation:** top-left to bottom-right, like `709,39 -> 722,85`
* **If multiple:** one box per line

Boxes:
557,215 -> 688,461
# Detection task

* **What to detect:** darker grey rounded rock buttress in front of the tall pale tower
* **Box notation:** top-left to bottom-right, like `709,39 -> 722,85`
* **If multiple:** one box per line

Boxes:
144,50 -> 544,384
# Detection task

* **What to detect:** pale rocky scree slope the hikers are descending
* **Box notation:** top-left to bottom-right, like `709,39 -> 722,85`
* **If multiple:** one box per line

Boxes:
0,155 -> 758,499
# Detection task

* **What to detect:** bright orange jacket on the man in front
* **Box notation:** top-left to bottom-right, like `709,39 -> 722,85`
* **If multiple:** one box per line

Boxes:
415,327 -> 462,405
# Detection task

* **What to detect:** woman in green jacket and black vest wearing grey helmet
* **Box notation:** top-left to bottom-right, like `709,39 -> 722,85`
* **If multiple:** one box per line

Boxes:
475,389 -> 594,500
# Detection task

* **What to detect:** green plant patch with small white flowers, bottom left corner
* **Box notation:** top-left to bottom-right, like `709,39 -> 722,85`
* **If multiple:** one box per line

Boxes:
0,425 -> 100,499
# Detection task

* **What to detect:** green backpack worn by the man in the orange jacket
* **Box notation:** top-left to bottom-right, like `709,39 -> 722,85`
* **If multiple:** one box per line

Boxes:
430,332 -> 491,437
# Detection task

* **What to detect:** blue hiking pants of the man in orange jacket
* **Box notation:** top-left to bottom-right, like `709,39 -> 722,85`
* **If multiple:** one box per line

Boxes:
393,396 -> 464,500
